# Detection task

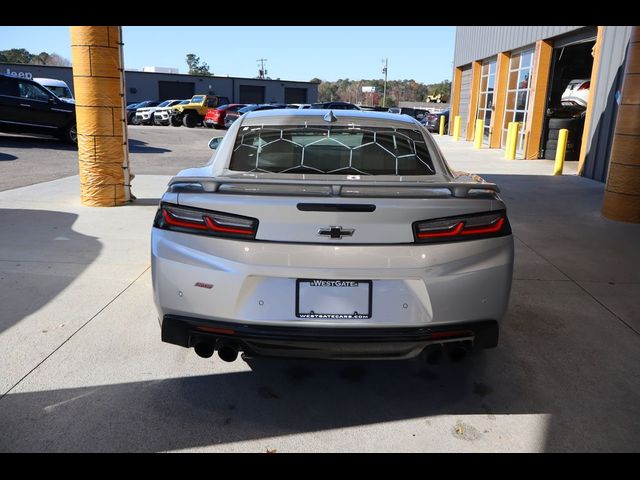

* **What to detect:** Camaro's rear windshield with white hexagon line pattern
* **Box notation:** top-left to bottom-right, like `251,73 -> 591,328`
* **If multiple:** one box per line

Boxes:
229,126 -> 435,175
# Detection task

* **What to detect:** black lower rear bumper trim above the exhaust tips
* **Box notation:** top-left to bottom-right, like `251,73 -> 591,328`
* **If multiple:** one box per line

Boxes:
162,315 -> 499,359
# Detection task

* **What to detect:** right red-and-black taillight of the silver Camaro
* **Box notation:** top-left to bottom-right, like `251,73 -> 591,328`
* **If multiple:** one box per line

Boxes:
413,210 -> 511,243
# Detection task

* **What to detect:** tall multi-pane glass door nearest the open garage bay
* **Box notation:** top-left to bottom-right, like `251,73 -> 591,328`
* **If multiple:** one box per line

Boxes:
502,48 -> 534,154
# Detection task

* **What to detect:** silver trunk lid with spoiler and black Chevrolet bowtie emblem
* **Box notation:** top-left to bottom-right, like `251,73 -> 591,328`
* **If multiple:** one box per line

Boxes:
170,175 -> 501,246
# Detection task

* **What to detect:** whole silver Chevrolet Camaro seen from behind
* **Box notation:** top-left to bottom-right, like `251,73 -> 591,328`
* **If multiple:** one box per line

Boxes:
151,109 -> 513,361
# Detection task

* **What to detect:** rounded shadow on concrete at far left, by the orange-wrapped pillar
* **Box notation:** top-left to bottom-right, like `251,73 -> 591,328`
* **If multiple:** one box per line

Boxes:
0,208 -> 102,333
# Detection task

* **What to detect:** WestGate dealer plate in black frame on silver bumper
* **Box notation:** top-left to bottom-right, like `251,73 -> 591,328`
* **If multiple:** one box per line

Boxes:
296,279 -> 372,319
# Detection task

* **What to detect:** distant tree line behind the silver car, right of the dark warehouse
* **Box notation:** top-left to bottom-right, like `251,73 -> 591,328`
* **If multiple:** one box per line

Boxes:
311,78 -> 451,107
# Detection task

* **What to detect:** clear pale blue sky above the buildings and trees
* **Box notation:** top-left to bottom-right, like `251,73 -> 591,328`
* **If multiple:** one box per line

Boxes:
0,26 -> 455,83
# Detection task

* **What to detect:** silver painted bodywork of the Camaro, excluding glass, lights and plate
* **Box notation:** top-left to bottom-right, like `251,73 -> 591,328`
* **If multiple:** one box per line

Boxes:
151,109 -> 514,354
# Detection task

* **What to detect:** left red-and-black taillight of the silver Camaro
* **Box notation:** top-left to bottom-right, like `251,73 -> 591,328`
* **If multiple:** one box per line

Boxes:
153,204 -> 258,240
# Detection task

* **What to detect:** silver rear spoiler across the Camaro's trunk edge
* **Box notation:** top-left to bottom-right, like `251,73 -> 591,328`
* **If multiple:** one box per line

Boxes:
169,175 -> 500,198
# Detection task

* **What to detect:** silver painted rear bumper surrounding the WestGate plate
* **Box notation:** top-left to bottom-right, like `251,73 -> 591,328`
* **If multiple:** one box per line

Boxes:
151,228 -> 513,328
